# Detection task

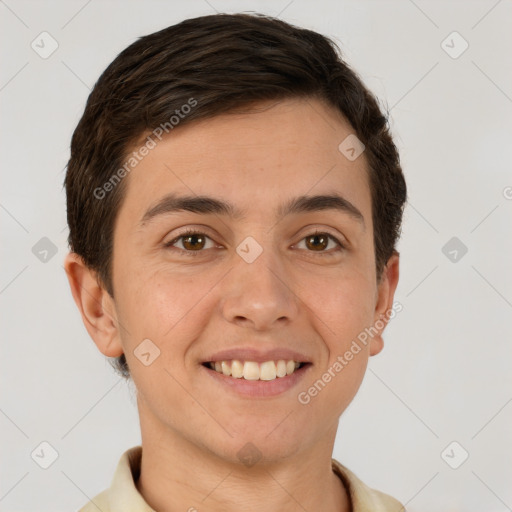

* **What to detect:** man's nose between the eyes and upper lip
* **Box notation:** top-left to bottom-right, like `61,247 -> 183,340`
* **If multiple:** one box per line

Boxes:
222,245 -> 299,331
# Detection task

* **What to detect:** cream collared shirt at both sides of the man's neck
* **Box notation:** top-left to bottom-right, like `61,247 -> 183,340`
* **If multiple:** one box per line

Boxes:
79,446 -> 405,512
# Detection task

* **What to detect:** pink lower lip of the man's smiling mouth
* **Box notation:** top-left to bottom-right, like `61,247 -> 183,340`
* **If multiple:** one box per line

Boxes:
201,363 -> 312,398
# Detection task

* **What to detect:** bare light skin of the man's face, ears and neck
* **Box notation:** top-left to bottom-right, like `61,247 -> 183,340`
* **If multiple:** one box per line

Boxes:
65,99 -> 399,512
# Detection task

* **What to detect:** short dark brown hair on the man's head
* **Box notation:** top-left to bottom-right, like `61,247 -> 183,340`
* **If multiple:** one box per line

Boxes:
65,14 -> 406,376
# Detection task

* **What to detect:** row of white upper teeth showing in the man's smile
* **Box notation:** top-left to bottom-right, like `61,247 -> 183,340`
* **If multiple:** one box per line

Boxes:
209,359 -> 300,380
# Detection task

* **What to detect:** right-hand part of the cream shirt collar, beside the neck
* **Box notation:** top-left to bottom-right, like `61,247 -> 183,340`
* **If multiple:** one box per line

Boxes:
332,459 -> 405,512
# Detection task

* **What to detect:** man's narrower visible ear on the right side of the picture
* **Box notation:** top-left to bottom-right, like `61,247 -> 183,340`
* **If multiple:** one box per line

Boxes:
370,251 -> 400,356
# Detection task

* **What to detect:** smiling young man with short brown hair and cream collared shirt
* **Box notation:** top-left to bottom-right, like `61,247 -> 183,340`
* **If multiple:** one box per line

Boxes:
65,14 -> 406,512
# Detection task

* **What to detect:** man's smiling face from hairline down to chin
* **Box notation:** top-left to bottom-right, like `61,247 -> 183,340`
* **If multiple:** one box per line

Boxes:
70,99 -> 398,461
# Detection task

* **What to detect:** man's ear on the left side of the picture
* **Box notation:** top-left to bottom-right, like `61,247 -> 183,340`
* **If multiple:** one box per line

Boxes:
64,252 -> 123,357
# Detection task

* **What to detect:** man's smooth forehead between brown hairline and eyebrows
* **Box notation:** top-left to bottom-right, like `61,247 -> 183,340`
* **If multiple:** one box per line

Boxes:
121,99 -> 370,224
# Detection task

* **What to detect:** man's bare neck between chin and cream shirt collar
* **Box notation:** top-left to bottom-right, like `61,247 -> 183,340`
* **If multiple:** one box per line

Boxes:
136,402 -> 350,512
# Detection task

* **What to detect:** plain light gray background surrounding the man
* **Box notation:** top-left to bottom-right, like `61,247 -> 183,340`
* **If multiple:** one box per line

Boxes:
0,0 -> 512,512
